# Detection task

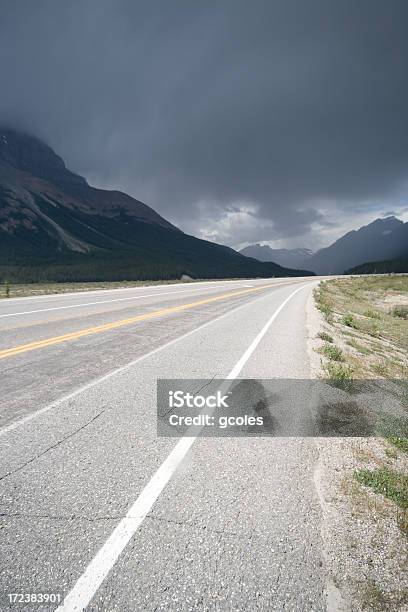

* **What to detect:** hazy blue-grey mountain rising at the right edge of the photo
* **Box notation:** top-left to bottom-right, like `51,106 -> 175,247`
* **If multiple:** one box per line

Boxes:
307,217 -> 408,274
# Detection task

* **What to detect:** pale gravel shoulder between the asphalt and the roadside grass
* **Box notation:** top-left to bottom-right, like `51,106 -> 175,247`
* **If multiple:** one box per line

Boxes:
307,281 -> 408,612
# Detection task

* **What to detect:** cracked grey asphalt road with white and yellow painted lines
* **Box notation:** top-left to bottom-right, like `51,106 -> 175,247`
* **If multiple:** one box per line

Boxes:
0,278 -> 325,611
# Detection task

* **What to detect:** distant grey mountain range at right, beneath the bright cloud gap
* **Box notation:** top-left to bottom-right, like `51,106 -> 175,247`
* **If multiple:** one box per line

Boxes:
241,217 -> 408,274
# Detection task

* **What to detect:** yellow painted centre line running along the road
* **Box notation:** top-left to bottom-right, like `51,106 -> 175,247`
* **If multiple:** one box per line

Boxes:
0,283 -> 287,359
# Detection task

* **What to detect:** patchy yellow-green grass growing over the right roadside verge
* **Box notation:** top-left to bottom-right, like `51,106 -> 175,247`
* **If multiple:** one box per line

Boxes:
315,276 -> 408,544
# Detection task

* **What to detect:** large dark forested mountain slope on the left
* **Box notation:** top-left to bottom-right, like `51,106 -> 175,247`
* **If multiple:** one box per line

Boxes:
0,128 -> 310,282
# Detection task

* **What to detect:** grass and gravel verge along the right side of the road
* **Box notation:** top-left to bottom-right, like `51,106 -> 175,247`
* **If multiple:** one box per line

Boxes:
313,275 -> 408,612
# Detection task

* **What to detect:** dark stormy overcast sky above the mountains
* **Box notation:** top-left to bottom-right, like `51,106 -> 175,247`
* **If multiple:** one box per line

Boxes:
0,0 -> 408,248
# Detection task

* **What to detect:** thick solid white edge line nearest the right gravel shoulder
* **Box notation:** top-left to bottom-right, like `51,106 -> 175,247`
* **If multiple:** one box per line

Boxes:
57,285 -> 307,612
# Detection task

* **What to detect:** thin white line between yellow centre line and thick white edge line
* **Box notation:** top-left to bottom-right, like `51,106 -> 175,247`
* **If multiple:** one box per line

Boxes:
0,285 -> 304,437
